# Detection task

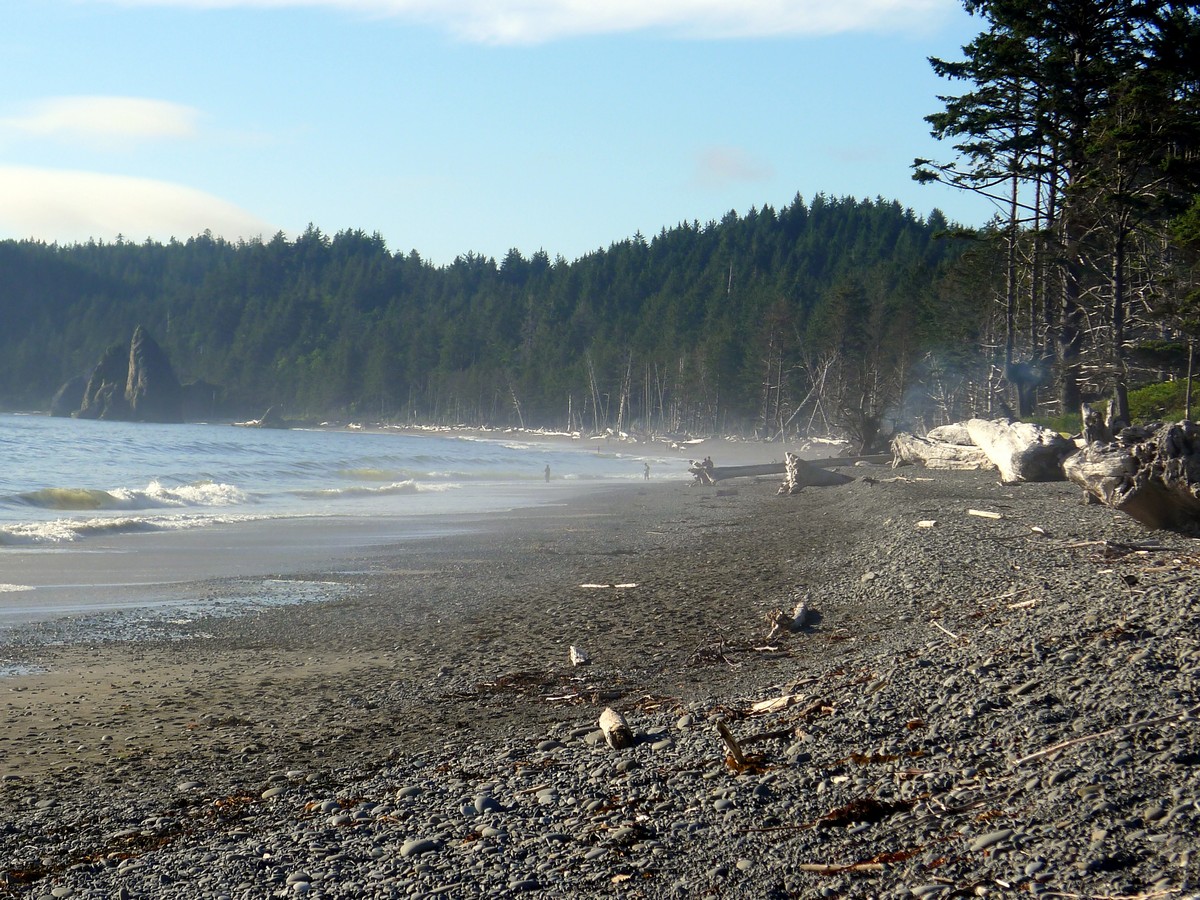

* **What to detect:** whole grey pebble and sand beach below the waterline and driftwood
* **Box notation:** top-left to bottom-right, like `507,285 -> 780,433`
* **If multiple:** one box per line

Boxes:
0,467 -> 1200,900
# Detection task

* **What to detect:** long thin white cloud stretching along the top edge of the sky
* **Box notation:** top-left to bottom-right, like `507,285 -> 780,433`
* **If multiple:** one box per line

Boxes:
77,0 -> 959,43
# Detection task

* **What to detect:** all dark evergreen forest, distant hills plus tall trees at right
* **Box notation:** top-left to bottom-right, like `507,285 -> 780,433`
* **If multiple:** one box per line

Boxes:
0,0 -> 1200,449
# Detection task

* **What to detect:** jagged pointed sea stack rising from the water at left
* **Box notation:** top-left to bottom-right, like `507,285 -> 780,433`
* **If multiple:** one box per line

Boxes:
63,325 -> 188,422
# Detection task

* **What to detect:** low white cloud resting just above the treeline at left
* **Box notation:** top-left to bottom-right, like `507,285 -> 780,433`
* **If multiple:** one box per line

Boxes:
0,166 -> 278,244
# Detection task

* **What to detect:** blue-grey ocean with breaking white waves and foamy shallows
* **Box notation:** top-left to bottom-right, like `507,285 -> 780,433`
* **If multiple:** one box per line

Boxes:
0,415 -> 688,637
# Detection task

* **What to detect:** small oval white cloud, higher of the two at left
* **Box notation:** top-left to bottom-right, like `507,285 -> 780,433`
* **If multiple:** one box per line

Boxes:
0,96 -> 199,144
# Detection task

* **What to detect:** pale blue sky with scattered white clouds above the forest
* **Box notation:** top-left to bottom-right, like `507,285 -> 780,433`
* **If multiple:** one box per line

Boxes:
0,0 -> 992,264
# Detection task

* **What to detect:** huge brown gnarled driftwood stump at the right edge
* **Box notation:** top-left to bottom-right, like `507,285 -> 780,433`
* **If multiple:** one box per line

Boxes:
1063,422 -> 1200,530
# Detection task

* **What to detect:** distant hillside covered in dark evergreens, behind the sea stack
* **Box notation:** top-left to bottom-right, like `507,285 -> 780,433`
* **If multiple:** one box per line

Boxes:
0,196 -> 974,436
